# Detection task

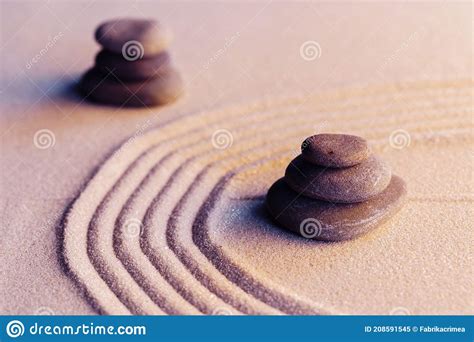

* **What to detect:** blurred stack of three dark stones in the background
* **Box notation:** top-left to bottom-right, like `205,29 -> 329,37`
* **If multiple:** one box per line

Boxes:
80,18 -> 183,107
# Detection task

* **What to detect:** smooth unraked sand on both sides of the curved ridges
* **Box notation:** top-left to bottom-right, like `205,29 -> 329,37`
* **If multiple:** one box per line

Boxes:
0,1 -> 474,314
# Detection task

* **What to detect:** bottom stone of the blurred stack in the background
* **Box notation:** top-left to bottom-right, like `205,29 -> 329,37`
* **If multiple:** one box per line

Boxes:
80,68 -> 184,107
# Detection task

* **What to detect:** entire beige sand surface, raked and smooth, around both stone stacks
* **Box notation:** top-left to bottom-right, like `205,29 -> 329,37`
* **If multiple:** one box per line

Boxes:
0,1 -> 474,314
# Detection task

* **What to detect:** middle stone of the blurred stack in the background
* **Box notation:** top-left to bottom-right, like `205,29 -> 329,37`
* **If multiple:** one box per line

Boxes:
95,50 -> 171,81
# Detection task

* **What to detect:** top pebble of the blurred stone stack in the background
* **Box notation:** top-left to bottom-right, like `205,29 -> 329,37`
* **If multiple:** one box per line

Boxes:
95,18 -> 172,56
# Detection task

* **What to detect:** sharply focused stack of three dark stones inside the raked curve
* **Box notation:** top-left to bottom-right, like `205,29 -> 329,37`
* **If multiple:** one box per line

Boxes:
266,134 -> 407,241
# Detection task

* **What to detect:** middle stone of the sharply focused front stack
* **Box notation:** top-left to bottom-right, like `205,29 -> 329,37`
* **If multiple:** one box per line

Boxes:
285,155 -> 392,203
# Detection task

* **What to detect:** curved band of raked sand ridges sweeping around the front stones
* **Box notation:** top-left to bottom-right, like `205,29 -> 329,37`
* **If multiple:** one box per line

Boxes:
64,81 -> 472,314
